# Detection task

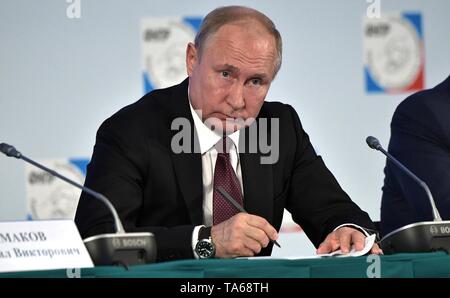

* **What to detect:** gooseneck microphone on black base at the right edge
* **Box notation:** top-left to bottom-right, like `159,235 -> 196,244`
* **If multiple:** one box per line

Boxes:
366,136 -> 450,254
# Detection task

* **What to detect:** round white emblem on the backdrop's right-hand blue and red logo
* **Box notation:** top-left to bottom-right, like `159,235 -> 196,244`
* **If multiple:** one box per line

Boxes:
365,16 -> 422,90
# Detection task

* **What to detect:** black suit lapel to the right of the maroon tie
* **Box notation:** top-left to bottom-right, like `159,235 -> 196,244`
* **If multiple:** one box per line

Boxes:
239,122 -> 273,223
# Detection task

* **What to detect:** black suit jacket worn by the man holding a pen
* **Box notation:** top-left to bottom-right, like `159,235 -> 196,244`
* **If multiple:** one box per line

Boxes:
75,80 -> 373,260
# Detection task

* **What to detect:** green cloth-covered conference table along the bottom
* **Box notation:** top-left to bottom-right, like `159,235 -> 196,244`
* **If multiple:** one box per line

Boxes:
0,252 -> 450,278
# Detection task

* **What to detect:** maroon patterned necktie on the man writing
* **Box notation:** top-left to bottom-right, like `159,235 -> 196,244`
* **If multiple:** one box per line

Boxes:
213,137 -> 243,225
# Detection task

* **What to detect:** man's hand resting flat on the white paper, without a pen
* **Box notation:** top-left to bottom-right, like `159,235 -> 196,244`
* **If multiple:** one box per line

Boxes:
317,227 -> 383,255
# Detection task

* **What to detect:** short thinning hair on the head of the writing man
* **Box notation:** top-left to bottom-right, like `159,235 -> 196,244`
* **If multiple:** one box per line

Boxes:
195,6 -> 283,78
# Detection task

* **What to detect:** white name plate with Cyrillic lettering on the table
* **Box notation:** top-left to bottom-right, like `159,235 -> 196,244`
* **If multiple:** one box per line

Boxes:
0,220 -> 94,272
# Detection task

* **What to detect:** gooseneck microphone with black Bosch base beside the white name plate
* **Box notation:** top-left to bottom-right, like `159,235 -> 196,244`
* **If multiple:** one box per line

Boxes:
0,143 -> 156,267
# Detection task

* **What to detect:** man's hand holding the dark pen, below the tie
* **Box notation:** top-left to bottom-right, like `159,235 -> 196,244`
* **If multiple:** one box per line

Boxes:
211,213 -> 278,258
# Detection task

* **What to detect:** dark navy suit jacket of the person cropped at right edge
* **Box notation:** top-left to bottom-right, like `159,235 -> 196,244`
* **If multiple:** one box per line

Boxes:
381,76 -> 450,235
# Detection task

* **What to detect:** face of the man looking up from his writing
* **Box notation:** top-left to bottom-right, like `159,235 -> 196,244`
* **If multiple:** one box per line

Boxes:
186,22 -> 277,133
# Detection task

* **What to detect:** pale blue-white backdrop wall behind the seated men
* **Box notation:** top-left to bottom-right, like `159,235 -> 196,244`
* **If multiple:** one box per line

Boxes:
0,0 -> 450,256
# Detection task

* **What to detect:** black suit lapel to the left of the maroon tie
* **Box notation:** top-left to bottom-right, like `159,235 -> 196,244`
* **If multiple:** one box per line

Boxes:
168,79 -> 203,225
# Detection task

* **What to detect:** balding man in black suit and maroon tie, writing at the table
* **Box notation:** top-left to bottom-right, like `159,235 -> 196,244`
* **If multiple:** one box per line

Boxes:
76,7 -> 381,260
